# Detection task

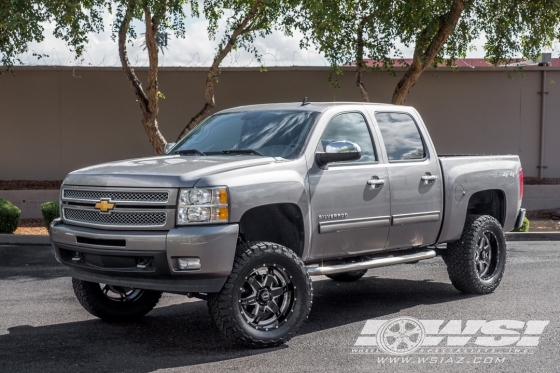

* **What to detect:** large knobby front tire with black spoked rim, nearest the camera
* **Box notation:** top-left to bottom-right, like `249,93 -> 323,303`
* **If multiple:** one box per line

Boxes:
208,242 -> 313,348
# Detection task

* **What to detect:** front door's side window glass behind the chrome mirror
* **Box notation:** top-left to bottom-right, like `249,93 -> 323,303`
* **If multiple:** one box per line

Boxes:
317,113 -> 377,163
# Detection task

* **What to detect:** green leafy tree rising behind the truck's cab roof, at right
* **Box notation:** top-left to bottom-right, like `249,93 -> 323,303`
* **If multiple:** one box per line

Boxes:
298,0 -> 560,104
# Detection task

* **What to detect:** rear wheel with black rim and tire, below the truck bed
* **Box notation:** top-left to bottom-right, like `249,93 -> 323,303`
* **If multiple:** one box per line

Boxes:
444,215 -> 507,294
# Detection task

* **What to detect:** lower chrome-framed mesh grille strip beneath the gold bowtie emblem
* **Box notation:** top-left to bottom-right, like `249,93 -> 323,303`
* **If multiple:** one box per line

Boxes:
63,208 -> 167,227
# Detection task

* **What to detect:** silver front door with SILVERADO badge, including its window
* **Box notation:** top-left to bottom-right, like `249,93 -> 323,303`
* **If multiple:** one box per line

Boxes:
309,112 -> 390,259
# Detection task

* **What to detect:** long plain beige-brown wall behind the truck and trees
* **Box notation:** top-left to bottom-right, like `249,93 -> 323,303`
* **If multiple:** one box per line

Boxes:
0,67 -> 560,180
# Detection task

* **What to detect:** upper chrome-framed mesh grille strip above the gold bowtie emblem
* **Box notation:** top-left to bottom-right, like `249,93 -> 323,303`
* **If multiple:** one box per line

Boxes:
63,189 -> 169,202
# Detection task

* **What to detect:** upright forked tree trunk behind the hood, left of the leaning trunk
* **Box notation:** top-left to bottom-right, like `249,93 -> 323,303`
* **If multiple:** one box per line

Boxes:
118,1 -> 167,155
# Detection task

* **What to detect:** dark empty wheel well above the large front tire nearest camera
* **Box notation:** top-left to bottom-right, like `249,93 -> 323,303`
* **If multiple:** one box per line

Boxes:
239,203 -> 305,258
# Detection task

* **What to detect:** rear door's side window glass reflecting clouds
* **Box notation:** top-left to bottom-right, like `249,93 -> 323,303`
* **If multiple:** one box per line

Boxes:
375,113 -> 426,162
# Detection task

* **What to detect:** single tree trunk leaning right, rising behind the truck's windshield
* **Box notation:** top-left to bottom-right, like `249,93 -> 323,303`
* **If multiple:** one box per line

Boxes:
177,0 -> 263,141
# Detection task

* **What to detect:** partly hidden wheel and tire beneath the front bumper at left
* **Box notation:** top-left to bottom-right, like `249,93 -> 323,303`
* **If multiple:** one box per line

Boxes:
72,278 -> 161,321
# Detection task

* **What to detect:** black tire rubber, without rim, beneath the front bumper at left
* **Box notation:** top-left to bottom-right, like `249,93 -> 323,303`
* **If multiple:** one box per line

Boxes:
72,278 -> 162,322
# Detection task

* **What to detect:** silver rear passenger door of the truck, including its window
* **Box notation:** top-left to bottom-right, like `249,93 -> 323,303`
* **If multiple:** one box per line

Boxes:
374,112 -> 443,249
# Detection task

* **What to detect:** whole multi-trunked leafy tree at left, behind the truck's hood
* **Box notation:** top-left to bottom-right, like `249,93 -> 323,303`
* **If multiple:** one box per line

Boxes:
4,0 -> 285,154
